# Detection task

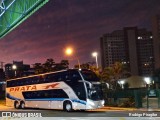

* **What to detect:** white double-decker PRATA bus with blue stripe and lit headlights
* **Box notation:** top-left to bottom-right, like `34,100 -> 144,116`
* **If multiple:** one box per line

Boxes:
6,69 -> 104,111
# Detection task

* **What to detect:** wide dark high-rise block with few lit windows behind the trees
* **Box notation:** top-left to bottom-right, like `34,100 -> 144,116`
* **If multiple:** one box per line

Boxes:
100,27 -> 154,76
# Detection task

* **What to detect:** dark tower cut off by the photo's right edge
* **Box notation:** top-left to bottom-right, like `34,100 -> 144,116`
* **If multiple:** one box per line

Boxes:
152,15 -> 160,69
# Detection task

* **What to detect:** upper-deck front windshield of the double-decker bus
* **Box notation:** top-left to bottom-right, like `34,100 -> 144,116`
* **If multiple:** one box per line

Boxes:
80,70 -> 100,82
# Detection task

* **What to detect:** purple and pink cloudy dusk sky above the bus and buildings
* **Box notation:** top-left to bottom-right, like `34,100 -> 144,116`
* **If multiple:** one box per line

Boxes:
0,0 -> 160,67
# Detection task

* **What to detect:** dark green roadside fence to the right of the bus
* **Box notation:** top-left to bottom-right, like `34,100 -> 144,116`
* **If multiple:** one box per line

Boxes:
104,89 -> 160,108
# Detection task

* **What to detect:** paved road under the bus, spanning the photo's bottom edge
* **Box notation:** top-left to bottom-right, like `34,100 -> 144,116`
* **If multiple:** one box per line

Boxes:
0,106 -> 160,120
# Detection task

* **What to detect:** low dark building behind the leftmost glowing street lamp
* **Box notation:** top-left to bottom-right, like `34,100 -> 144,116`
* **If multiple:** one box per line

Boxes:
5,61 -> 31,78
